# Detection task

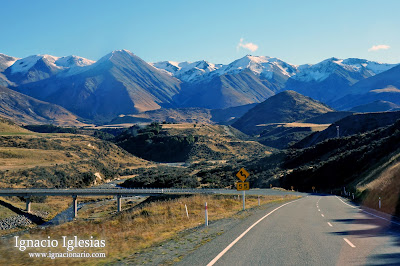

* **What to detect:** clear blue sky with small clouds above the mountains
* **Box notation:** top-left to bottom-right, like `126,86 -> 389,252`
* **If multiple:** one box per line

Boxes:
0,0 -> 400,64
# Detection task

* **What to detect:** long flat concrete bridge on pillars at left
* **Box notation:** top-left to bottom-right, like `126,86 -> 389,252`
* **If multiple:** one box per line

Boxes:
0,188 -> 218,218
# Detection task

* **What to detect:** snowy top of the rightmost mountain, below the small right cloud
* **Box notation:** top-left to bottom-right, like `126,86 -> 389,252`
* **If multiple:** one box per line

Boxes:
293,57 -> 396,82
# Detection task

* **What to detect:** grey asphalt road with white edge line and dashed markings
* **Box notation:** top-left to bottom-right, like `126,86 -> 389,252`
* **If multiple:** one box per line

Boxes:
179,195 -> 400,265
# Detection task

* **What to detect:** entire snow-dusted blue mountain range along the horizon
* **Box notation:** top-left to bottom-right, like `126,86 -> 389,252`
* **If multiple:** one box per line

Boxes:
0,50 -> 400,123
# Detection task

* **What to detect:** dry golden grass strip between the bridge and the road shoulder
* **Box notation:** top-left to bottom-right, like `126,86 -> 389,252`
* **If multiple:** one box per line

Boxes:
0,195 -> 295,265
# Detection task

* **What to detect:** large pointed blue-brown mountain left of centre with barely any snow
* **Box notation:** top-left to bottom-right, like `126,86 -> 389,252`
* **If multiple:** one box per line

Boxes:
18,50 -> 180,121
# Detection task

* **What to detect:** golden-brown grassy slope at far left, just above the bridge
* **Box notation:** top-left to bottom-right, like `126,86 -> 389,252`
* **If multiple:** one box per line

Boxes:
0,118 -> 152,187
